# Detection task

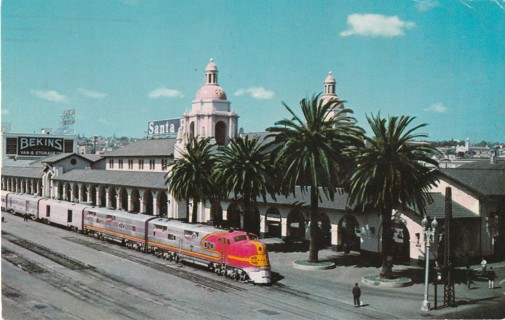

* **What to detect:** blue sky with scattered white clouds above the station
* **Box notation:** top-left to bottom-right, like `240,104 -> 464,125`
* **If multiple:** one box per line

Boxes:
1,0 -> 505,142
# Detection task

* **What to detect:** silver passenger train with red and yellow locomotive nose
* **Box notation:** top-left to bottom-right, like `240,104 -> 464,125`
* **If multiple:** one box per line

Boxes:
1,190 -> 272,284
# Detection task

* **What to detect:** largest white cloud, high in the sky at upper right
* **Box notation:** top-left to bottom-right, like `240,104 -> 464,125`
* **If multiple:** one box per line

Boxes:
340,13 -> 415,38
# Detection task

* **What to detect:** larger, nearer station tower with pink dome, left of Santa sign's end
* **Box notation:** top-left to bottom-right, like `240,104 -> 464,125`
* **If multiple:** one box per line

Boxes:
174,59 -> 238,159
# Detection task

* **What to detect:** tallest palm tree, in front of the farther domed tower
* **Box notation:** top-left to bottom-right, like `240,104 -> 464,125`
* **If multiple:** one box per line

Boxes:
267,95 -> 363,262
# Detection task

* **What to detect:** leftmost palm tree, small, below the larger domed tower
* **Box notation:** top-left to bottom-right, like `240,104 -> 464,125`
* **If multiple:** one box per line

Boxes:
165,137 -> 215,223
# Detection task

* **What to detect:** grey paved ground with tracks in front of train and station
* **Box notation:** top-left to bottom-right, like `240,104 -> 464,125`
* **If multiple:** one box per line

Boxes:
2,214 -> 505,320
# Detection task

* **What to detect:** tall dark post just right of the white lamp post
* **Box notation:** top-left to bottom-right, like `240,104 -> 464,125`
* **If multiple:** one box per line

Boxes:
444,187 -> 456,307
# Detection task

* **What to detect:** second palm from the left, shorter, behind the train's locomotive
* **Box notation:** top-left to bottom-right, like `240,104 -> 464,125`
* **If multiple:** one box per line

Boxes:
213,136 -> 275,234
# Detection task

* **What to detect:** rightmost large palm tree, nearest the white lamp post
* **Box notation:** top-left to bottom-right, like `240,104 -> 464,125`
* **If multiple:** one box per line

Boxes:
347,114 -> 438,278
